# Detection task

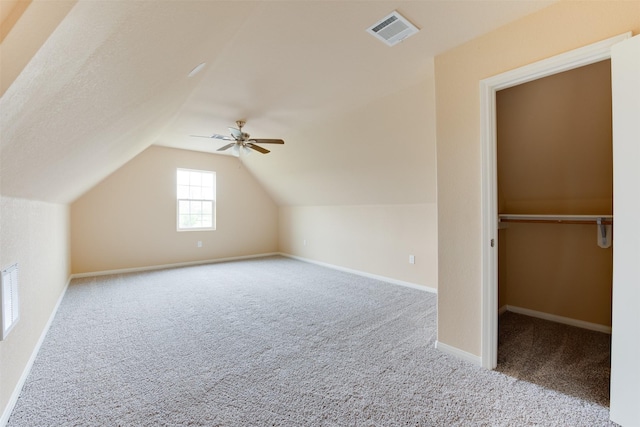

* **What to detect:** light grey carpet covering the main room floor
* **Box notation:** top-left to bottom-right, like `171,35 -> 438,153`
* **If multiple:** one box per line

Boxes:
9,257 -> 613,427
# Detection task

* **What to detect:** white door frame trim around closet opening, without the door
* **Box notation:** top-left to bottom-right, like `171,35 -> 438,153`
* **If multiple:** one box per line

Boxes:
480,32 -> 631,369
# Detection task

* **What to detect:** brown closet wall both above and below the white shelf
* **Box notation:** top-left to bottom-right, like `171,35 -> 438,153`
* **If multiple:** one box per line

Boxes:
496,61 -> 613,326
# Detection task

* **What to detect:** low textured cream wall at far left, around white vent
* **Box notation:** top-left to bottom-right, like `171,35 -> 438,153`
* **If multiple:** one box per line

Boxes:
0,197 -> 69,422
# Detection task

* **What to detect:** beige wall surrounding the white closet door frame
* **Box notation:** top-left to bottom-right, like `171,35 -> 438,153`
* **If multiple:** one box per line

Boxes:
435,1 -> 640,355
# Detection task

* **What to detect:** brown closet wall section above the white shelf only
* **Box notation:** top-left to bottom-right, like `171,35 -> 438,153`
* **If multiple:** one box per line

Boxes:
496,60 -> 613,215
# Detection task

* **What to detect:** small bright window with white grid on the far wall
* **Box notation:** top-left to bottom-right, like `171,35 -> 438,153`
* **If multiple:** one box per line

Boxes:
177,169 -> 216,231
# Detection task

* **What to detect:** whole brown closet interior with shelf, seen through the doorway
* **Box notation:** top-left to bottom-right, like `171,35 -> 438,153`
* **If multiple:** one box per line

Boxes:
496,60 -> 614,404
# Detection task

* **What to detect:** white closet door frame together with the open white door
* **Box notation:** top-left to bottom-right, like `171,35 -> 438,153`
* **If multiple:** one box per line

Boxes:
480,32 -> 640,425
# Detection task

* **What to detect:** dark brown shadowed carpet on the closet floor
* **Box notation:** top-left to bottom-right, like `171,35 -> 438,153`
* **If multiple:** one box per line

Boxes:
496,312 -> 611,407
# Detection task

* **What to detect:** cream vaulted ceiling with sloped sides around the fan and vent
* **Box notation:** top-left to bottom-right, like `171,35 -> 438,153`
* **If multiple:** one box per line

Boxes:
0,0 -> 551,204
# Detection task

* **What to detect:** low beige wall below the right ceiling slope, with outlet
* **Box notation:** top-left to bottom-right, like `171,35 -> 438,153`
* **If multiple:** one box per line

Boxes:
280,203 -> 438,288
